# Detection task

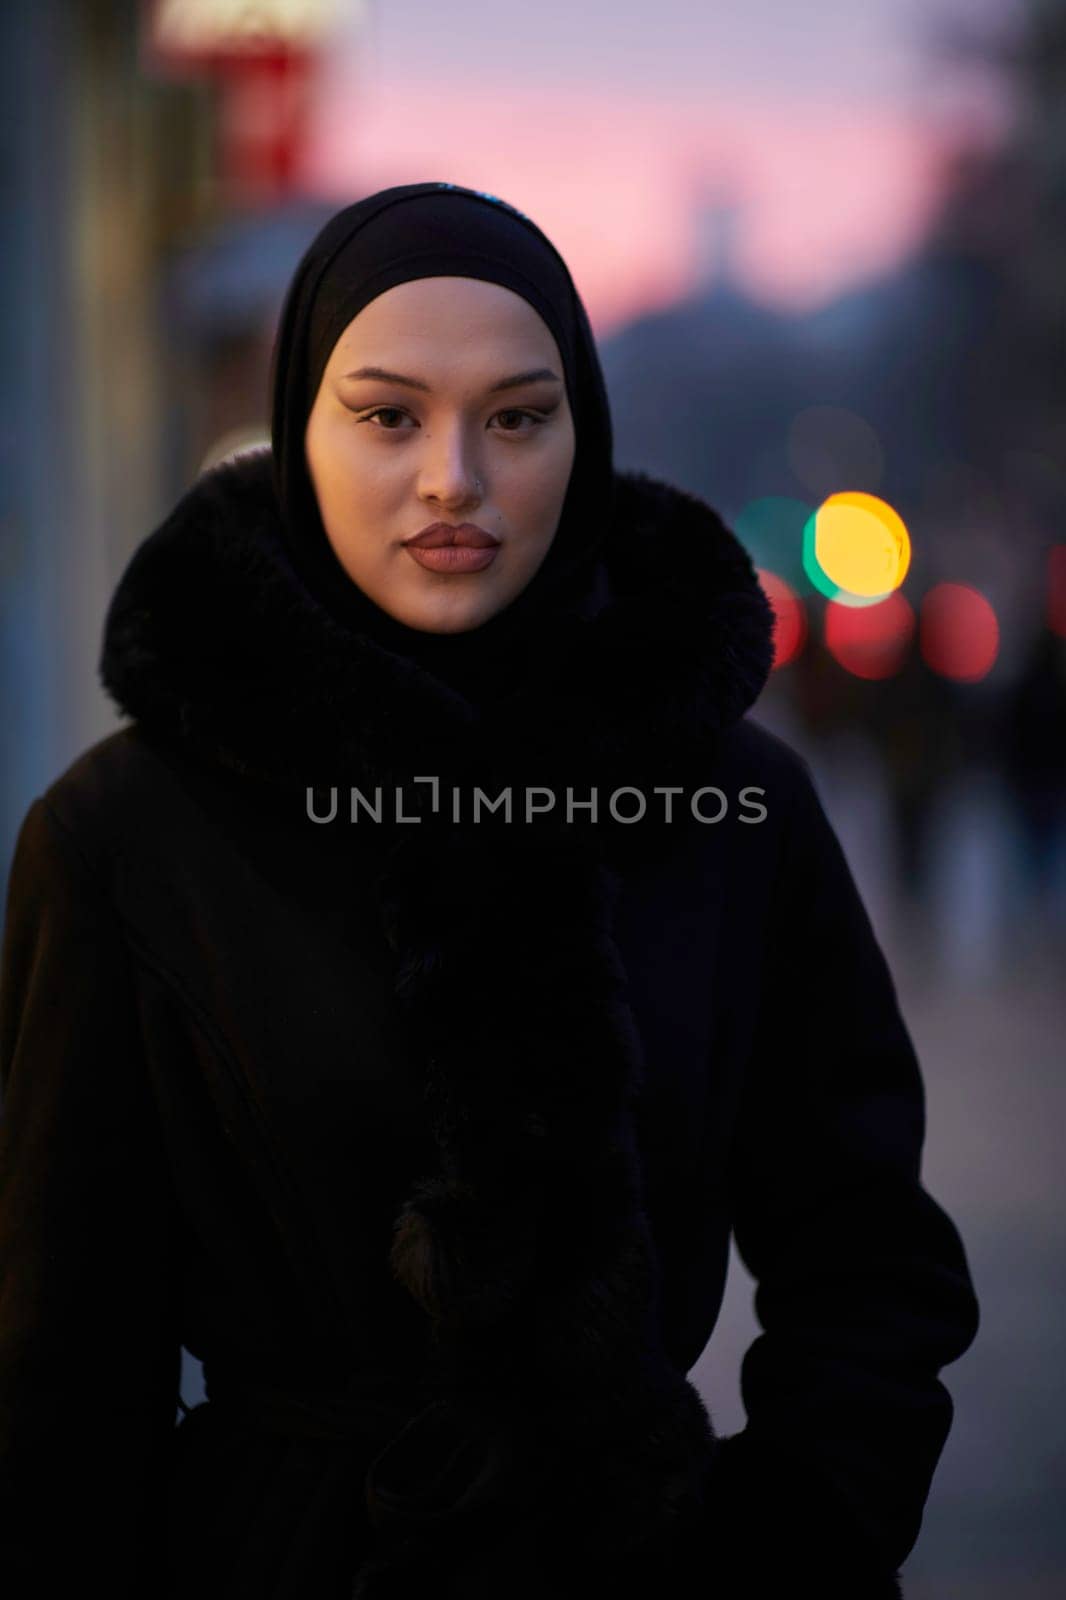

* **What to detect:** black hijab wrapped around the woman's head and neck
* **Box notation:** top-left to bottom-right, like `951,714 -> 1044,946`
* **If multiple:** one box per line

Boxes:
271,182 -> 615,702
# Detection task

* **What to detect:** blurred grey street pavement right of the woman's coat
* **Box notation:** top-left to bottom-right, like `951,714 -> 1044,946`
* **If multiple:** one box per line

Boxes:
693,739 -> 1066,1600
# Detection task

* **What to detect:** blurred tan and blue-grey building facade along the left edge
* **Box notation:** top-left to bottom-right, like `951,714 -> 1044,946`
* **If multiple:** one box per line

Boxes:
0,0 -> 214,896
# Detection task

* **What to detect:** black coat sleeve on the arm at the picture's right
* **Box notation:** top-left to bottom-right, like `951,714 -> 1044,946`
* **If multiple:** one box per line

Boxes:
704,757 -> 978,1600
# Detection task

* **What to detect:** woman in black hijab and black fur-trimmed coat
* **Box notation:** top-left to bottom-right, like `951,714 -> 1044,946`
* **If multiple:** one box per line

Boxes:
0,182 -> 978,1600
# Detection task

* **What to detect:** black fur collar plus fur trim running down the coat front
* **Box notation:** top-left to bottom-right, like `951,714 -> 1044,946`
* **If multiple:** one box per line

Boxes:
101,454 -> 771,1600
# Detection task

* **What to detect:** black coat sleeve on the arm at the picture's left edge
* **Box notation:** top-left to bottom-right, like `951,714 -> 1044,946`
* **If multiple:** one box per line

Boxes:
0,797 -> 181,1600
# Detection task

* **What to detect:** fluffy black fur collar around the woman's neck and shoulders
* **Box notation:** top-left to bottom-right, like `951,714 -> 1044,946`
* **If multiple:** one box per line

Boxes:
99,450 -> 773,812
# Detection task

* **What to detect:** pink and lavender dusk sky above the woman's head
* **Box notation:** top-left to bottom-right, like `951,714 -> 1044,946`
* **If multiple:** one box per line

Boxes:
302,0 -> 1016,334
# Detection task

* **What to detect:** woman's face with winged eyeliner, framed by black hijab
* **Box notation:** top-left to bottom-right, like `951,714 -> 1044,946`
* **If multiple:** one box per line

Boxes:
304,277 -> 576,634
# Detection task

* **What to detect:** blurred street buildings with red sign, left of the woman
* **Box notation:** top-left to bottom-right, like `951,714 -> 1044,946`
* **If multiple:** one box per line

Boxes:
0,0 -> 354,888
